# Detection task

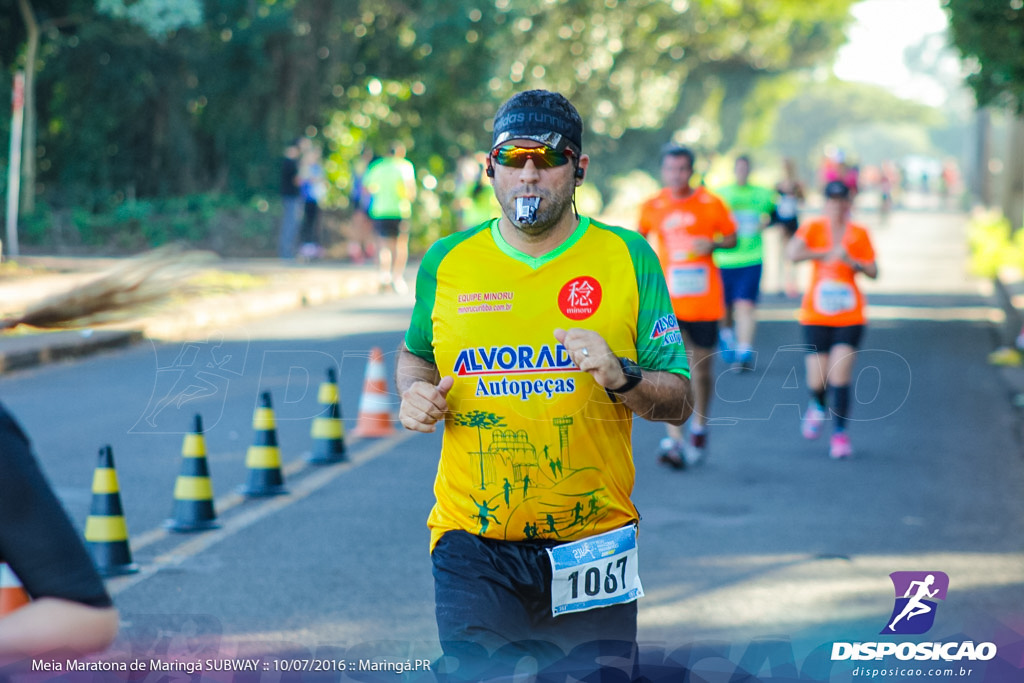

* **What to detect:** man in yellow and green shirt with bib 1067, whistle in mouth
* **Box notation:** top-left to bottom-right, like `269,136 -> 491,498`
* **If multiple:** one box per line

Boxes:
396,90 -> 692,680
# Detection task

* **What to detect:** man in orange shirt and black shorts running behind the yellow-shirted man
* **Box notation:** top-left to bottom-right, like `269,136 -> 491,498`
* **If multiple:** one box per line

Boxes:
639,142 -> 736,469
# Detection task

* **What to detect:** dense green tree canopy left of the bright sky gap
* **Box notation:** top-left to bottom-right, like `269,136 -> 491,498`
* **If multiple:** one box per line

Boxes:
0,0 -> 855,248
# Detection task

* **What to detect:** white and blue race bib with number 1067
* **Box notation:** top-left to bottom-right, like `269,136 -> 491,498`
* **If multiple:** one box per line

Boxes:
548,524 -> 643,616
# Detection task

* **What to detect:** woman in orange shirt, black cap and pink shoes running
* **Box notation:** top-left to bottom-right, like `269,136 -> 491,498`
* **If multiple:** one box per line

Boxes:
786,180 -> 879,458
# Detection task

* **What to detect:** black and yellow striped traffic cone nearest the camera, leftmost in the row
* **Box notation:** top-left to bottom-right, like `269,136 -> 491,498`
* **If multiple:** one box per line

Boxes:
85,445 -> 138,577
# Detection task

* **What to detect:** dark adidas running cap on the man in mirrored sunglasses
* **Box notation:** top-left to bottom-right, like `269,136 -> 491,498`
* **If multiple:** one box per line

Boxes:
490,90 -> 583,157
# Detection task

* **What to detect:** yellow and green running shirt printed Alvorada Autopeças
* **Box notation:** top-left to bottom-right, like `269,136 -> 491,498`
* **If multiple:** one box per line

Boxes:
406,217 -> 689,549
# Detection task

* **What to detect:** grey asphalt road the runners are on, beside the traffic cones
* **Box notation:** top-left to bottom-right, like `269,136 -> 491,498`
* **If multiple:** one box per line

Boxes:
0,210 -> 1024,681
